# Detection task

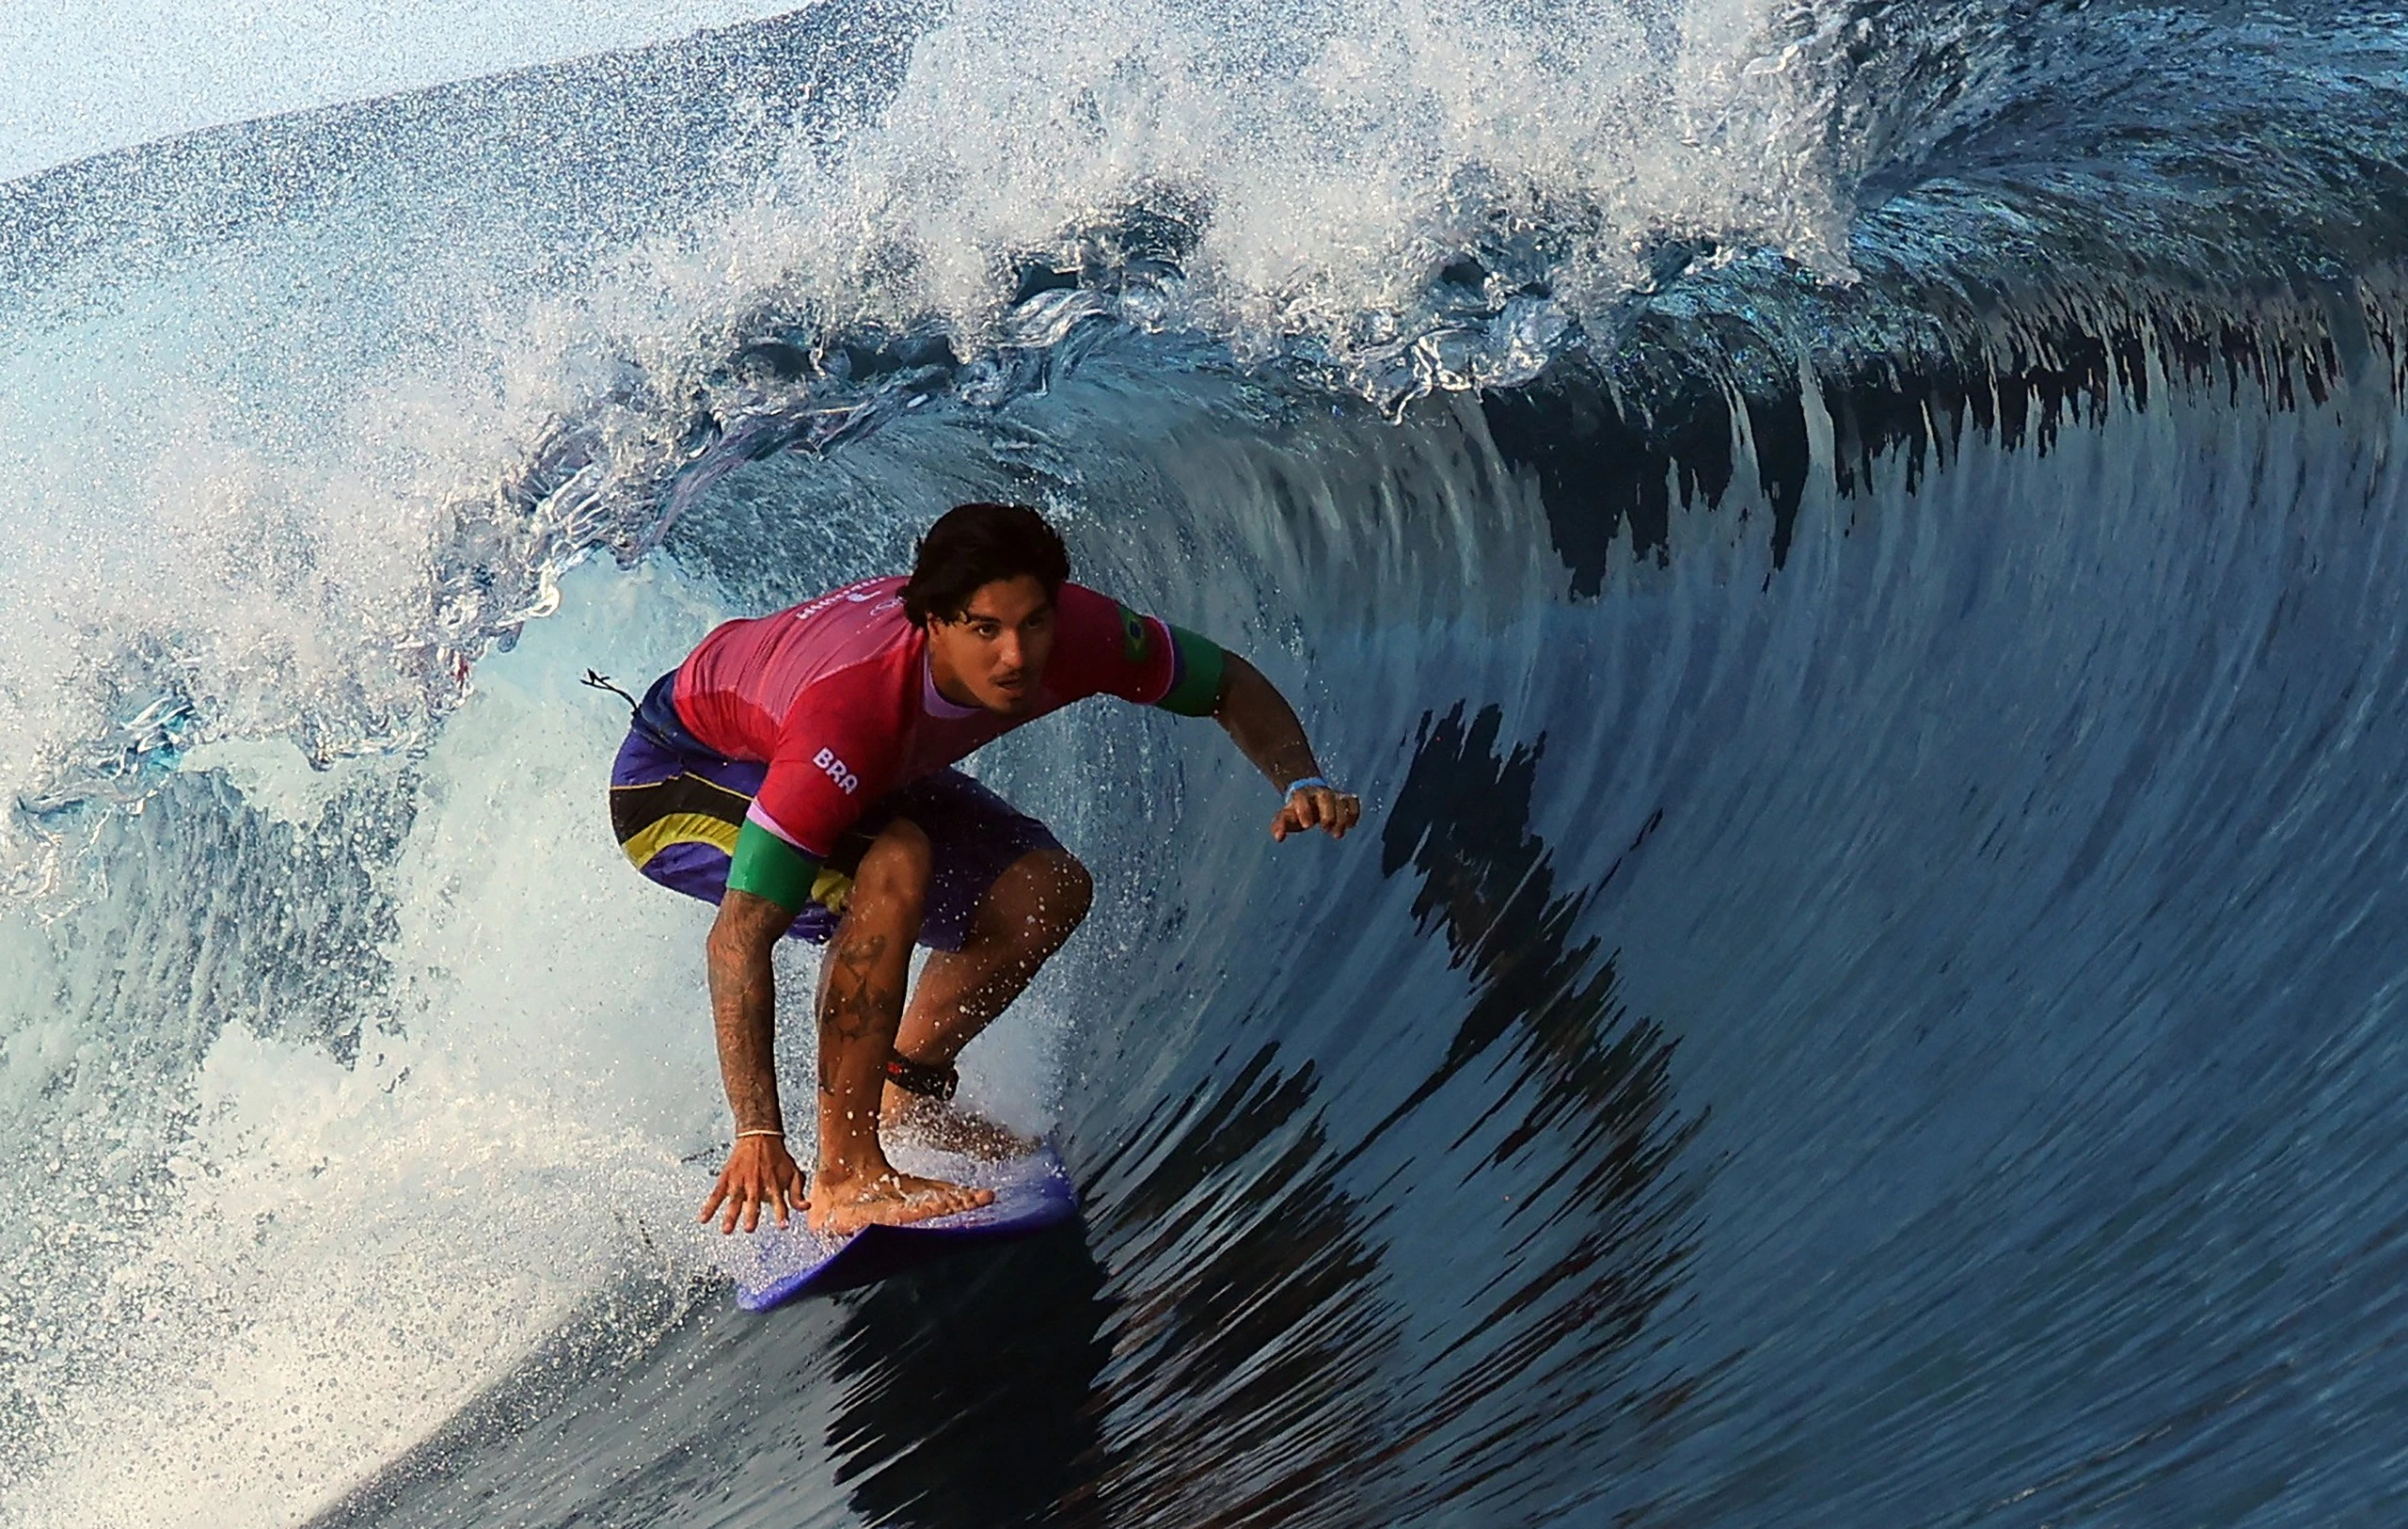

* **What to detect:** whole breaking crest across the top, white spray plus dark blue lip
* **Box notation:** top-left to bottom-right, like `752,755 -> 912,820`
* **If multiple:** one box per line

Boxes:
0,5 -> 2400,862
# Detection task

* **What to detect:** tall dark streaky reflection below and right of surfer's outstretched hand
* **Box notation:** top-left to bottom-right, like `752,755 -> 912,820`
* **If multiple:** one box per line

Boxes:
1358,706 -> 1703,1512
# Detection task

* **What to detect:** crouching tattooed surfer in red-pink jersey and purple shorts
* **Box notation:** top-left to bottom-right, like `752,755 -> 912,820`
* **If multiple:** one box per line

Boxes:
610,503 -> 1363,1233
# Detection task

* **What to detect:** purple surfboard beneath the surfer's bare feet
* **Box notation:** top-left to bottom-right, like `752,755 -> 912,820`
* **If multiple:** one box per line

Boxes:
705,1141 -> 1079,1313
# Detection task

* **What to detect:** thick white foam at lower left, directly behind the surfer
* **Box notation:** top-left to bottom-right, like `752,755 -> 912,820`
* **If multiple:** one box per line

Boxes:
0,563 -> 725,1526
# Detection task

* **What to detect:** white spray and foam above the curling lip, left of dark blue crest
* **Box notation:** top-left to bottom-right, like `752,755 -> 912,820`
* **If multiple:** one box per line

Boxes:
0,0 -> 1837,871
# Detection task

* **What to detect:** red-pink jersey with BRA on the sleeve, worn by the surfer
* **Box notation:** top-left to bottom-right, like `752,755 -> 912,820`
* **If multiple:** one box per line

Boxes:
676,578 -> 1182,857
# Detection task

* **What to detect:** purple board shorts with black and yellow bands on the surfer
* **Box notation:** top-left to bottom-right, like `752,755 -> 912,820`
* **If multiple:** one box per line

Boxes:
610,672 -> 1062,951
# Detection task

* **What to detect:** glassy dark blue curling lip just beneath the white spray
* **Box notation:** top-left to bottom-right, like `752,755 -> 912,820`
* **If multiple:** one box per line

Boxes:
380,5 -> 2408,770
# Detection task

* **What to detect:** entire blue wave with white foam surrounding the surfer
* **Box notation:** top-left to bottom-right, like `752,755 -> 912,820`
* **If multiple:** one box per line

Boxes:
0,0 -> 2408,1526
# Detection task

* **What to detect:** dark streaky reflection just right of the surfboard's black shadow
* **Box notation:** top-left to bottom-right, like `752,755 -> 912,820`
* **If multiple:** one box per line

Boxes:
1065,1045 -> 1406,1529
